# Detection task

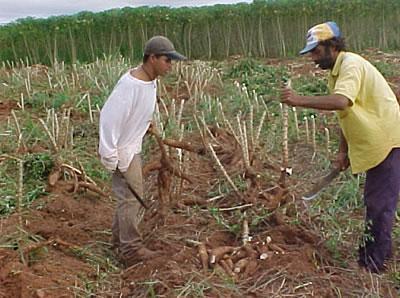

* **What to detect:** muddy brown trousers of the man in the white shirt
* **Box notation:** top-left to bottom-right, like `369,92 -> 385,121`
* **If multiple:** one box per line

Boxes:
112,154 -> 144,260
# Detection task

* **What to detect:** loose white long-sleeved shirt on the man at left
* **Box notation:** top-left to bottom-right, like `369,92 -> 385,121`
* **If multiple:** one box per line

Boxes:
99,71 -> 157,172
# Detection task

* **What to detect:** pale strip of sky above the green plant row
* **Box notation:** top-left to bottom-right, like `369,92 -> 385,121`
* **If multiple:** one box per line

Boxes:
0,0 -> 252,24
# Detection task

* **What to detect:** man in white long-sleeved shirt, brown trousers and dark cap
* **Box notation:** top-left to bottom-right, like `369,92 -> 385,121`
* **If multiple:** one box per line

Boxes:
99,36 -> 186,266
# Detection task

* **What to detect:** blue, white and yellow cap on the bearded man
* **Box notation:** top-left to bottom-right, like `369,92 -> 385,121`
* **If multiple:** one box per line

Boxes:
300,22 -> 342,55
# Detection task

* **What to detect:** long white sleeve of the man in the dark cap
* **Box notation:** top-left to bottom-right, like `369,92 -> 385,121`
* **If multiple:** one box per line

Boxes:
99,79 -> 132,171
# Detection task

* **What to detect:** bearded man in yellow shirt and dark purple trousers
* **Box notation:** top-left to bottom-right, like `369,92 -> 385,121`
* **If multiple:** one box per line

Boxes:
281,22 -> 400,272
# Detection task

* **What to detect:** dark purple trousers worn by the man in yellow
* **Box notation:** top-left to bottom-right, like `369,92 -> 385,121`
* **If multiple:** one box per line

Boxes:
359,148 -> 400,272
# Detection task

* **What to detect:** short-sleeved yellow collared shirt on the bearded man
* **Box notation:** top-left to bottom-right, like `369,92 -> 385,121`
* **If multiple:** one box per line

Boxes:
328,52 -> 400,173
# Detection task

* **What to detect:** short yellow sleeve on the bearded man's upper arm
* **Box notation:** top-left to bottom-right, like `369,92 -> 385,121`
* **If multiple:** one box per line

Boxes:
332,59 -> 363,104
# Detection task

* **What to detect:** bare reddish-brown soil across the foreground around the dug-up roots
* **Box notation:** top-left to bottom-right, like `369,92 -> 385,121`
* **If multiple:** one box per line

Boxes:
0,52 -> 399,298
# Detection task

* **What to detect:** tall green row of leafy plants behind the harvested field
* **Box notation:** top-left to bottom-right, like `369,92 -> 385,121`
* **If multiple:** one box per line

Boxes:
0,0 -> 400,64
